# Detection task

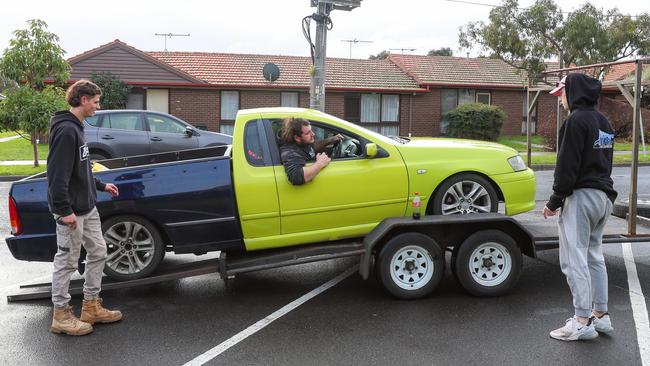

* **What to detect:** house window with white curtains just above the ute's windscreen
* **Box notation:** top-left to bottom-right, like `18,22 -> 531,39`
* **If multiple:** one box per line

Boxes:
344,94 -> 399,136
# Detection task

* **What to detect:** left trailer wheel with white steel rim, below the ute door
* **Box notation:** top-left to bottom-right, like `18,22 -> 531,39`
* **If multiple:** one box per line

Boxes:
375,233 -> 445,299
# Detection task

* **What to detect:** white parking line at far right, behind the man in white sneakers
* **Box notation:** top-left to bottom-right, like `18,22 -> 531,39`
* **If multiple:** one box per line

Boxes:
622,243 -> 650,366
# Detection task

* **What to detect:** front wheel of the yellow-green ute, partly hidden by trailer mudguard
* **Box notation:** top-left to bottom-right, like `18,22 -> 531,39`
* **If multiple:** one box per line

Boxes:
433,173 -> 499,215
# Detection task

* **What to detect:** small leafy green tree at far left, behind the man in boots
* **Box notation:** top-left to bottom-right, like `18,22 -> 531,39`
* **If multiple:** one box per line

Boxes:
0,19 -> 70,166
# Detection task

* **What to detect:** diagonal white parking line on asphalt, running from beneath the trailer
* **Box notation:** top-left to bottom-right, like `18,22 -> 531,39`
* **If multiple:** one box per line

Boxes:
185,265 -> 359,366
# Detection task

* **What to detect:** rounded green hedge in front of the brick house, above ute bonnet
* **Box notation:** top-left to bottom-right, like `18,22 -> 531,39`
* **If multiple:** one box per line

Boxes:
443,103 -> 507,141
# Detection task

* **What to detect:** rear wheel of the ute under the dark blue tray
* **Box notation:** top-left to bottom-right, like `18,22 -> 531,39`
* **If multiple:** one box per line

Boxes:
102,215 -> 165,281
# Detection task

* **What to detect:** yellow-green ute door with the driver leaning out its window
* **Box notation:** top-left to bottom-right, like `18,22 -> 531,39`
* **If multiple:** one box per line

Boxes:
274,120 -> 408,244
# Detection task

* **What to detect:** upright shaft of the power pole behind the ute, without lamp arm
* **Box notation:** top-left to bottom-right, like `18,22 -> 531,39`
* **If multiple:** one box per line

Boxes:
309,2 -> 332,112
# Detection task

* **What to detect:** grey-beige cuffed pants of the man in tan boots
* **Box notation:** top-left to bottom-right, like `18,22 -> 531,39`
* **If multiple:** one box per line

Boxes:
52,208 -> 106,307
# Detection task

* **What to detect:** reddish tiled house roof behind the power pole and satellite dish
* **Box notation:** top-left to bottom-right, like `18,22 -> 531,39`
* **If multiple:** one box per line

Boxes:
147,52 -> 422,91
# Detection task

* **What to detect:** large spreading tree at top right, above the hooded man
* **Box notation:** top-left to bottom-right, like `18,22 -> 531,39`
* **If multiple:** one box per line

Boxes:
458,0 -> 650,79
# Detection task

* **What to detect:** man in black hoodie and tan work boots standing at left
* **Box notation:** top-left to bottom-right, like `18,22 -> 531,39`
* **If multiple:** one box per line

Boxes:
47,80 -> 122,335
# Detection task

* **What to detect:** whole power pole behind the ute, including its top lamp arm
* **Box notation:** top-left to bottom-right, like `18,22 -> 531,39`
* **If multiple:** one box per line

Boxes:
308,0 -> 361,112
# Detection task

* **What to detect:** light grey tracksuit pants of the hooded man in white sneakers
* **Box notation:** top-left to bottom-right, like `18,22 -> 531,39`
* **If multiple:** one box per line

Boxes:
558,188 -> 612,317
